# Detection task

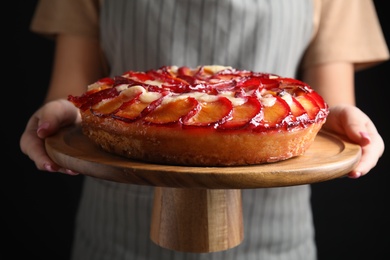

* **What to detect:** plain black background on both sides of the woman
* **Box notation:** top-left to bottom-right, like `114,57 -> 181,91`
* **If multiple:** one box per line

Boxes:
4,0 -> 390,260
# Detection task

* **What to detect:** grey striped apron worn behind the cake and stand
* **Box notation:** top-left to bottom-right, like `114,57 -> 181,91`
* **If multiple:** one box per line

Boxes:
72,0 -> 316,260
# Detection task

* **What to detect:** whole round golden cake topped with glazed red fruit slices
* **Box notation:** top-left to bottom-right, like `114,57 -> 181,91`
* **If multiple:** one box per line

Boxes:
68,65 -> 329,167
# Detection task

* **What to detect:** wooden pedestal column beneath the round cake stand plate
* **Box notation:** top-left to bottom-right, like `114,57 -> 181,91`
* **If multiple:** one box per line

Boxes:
150,187 -> 244,253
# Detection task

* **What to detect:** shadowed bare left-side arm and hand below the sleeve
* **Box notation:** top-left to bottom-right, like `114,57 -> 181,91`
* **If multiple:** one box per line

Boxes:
20,35 -> 104,174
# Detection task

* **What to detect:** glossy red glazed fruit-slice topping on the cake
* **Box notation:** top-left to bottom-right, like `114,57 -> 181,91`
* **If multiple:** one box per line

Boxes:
68,66 -> 329,131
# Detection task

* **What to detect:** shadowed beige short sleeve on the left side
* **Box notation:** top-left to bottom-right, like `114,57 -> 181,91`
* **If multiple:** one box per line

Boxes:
30,0 -> 100,38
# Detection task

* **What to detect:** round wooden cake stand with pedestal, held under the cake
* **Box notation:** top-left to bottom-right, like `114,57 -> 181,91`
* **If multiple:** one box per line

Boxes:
46,126 -> 361,253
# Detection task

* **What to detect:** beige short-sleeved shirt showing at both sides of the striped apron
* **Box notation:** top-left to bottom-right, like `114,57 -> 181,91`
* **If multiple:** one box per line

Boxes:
31,0 -> 390,69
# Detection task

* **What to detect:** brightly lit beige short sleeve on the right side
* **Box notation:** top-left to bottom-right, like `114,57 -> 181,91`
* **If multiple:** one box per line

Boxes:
302,0 -> 389,69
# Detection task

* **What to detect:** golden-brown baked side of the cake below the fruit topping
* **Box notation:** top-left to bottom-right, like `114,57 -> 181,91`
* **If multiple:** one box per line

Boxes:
71,65 -> 328,166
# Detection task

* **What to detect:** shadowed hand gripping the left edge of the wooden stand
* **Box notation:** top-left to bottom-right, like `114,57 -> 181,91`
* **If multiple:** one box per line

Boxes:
20,99 -> 81,175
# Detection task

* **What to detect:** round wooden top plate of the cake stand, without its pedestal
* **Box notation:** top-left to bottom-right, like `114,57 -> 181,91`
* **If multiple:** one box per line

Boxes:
46,126 -> 361,189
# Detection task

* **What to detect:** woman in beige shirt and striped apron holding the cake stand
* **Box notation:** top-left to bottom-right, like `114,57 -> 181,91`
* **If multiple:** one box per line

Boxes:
21,0 -> 389,260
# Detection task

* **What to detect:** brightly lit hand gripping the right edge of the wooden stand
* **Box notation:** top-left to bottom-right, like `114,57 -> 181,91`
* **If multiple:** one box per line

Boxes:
324,105 -> 385,178
